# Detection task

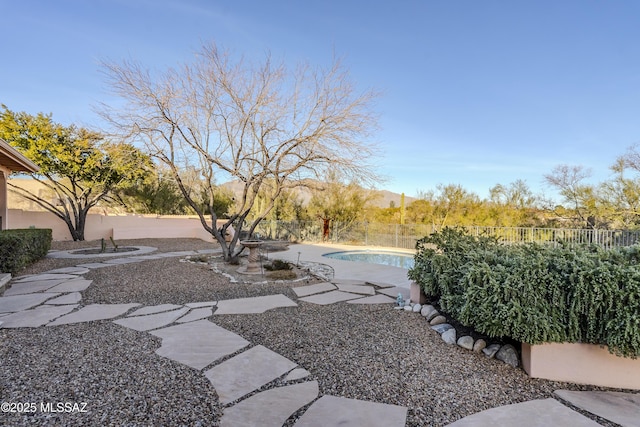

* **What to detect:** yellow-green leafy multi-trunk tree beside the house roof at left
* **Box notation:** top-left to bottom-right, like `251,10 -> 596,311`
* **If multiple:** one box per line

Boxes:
0,105 -> 151,240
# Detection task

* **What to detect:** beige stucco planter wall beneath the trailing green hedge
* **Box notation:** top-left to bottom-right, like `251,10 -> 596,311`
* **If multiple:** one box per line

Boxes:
522,343 -> 640,390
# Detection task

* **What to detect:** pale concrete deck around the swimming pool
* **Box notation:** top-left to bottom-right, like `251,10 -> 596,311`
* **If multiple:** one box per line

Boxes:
269,243 -> 415,289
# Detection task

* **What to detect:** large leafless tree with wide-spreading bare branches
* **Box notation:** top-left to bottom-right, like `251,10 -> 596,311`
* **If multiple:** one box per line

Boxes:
103,44 -> 376,260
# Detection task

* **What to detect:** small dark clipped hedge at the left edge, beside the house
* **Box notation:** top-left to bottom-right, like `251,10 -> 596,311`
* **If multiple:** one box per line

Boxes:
0,228 -> 52,274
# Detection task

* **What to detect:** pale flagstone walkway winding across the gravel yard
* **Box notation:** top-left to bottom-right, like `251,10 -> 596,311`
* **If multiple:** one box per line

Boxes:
0,245 -> 640,427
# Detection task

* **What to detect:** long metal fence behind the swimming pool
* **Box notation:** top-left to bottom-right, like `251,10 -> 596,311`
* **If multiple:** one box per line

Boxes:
255,221 -> 640,249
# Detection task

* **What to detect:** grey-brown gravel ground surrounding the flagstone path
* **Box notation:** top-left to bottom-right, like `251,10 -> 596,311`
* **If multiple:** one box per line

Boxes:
0,239 -> 613,426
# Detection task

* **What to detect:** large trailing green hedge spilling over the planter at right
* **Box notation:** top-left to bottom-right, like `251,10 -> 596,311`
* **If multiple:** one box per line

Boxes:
409,228 -> 640,358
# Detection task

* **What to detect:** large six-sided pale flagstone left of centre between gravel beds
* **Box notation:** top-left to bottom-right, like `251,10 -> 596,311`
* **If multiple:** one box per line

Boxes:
151,320 -> 249,369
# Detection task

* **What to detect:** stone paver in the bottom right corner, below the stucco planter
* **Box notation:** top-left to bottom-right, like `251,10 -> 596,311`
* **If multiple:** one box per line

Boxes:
555,390 -> 640,427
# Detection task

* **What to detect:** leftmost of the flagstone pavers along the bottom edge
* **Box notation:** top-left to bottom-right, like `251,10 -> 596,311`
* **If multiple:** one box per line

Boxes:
220,381 -> 318,427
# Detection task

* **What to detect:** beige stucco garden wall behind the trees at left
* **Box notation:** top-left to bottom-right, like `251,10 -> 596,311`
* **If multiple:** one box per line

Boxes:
9,209 -> 222,242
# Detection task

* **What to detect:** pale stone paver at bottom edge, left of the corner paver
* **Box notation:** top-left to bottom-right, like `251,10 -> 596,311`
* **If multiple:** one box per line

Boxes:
444,398 -> 600,427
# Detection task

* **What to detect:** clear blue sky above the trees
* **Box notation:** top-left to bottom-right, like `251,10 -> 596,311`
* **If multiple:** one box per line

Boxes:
0,0 -> 640,201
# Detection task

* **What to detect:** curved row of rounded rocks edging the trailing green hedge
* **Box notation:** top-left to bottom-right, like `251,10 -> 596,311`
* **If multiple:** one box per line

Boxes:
394,300 -> 521,368
